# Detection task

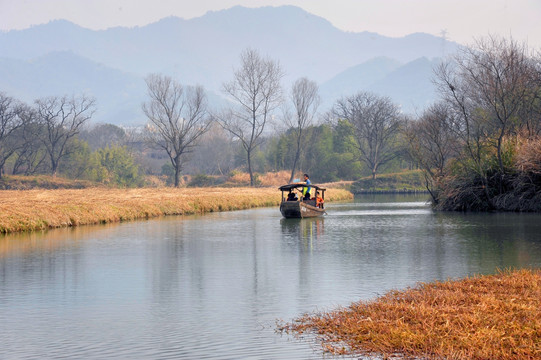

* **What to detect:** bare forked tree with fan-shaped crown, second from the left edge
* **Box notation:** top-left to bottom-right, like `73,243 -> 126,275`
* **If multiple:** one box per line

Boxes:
36,95 -> 95,176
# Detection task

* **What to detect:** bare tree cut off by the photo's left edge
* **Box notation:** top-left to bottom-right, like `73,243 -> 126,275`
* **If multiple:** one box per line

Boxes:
0,93 -> 24,177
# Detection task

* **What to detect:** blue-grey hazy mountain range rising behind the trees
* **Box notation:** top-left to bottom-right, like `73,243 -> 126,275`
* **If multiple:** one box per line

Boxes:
0,6 -> 458,125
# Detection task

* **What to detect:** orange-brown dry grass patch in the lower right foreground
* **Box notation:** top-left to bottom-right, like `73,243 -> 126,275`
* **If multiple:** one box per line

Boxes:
280,270 -> 541,360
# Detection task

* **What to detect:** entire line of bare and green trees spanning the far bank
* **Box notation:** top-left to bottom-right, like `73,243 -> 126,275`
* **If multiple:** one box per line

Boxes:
0,37 -> 541,210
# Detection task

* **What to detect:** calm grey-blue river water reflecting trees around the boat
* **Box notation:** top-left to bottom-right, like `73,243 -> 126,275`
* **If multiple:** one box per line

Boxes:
0,196 -> 541,359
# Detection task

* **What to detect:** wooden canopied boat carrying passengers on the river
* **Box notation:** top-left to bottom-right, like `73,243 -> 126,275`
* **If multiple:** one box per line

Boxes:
278,182 -> 326,219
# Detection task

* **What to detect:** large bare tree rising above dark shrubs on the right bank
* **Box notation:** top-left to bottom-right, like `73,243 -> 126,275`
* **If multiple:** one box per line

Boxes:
436,37 -> 540,173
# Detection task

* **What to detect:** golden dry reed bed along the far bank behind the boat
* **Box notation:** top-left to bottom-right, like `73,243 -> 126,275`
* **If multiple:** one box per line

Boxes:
0,188 -> 353,233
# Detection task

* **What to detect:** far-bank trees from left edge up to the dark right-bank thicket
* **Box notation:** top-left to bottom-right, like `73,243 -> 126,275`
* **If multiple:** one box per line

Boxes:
0,49 -> 410,186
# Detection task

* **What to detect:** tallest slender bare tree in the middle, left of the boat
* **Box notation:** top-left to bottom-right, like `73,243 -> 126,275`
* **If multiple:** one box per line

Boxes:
219,49 -> 284,186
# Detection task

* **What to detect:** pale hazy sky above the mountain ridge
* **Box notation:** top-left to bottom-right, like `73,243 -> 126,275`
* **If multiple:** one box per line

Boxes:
0,0 -> 541,50
